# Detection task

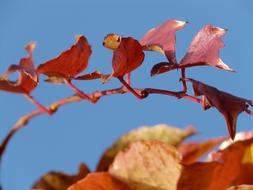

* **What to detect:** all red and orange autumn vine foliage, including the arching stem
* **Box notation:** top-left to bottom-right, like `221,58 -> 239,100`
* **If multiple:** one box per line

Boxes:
0,19 -> 253,190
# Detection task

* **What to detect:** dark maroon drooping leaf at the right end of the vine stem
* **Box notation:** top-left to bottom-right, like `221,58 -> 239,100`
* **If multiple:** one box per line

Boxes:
186,79 -> 253,139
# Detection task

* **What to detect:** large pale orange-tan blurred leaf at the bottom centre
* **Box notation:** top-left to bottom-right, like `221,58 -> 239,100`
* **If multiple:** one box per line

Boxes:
109,141 -> 181,190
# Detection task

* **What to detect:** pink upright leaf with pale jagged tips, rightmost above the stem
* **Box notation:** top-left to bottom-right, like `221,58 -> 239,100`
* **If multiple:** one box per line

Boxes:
180,25 -> 234,71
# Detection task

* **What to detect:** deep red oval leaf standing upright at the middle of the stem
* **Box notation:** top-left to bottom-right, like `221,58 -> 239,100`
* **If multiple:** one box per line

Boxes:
112,37 -> 144,77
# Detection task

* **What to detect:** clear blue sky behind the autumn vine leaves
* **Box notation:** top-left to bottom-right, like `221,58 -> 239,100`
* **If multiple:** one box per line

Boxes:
0,0 -> 253,190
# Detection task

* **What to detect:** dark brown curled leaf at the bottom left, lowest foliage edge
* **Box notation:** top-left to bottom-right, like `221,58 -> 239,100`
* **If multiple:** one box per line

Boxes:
32,164 -> 89,190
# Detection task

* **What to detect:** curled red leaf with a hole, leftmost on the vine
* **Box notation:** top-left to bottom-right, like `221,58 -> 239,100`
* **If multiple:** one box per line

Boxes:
0,42 -> 39,94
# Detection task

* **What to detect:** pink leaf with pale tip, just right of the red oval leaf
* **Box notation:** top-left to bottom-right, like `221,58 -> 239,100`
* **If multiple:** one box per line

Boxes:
140,19 -> 187,64
